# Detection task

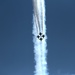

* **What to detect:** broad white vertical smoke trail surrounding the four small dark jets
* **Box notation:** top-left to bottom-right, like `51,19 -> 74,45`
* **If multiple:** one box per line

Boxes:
33,0 -> 48,75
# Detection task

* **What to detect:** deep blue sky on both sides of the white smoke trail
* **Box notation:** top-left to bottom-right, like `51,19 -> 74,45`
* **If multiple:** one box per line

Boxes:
0,0 -> 75,75
